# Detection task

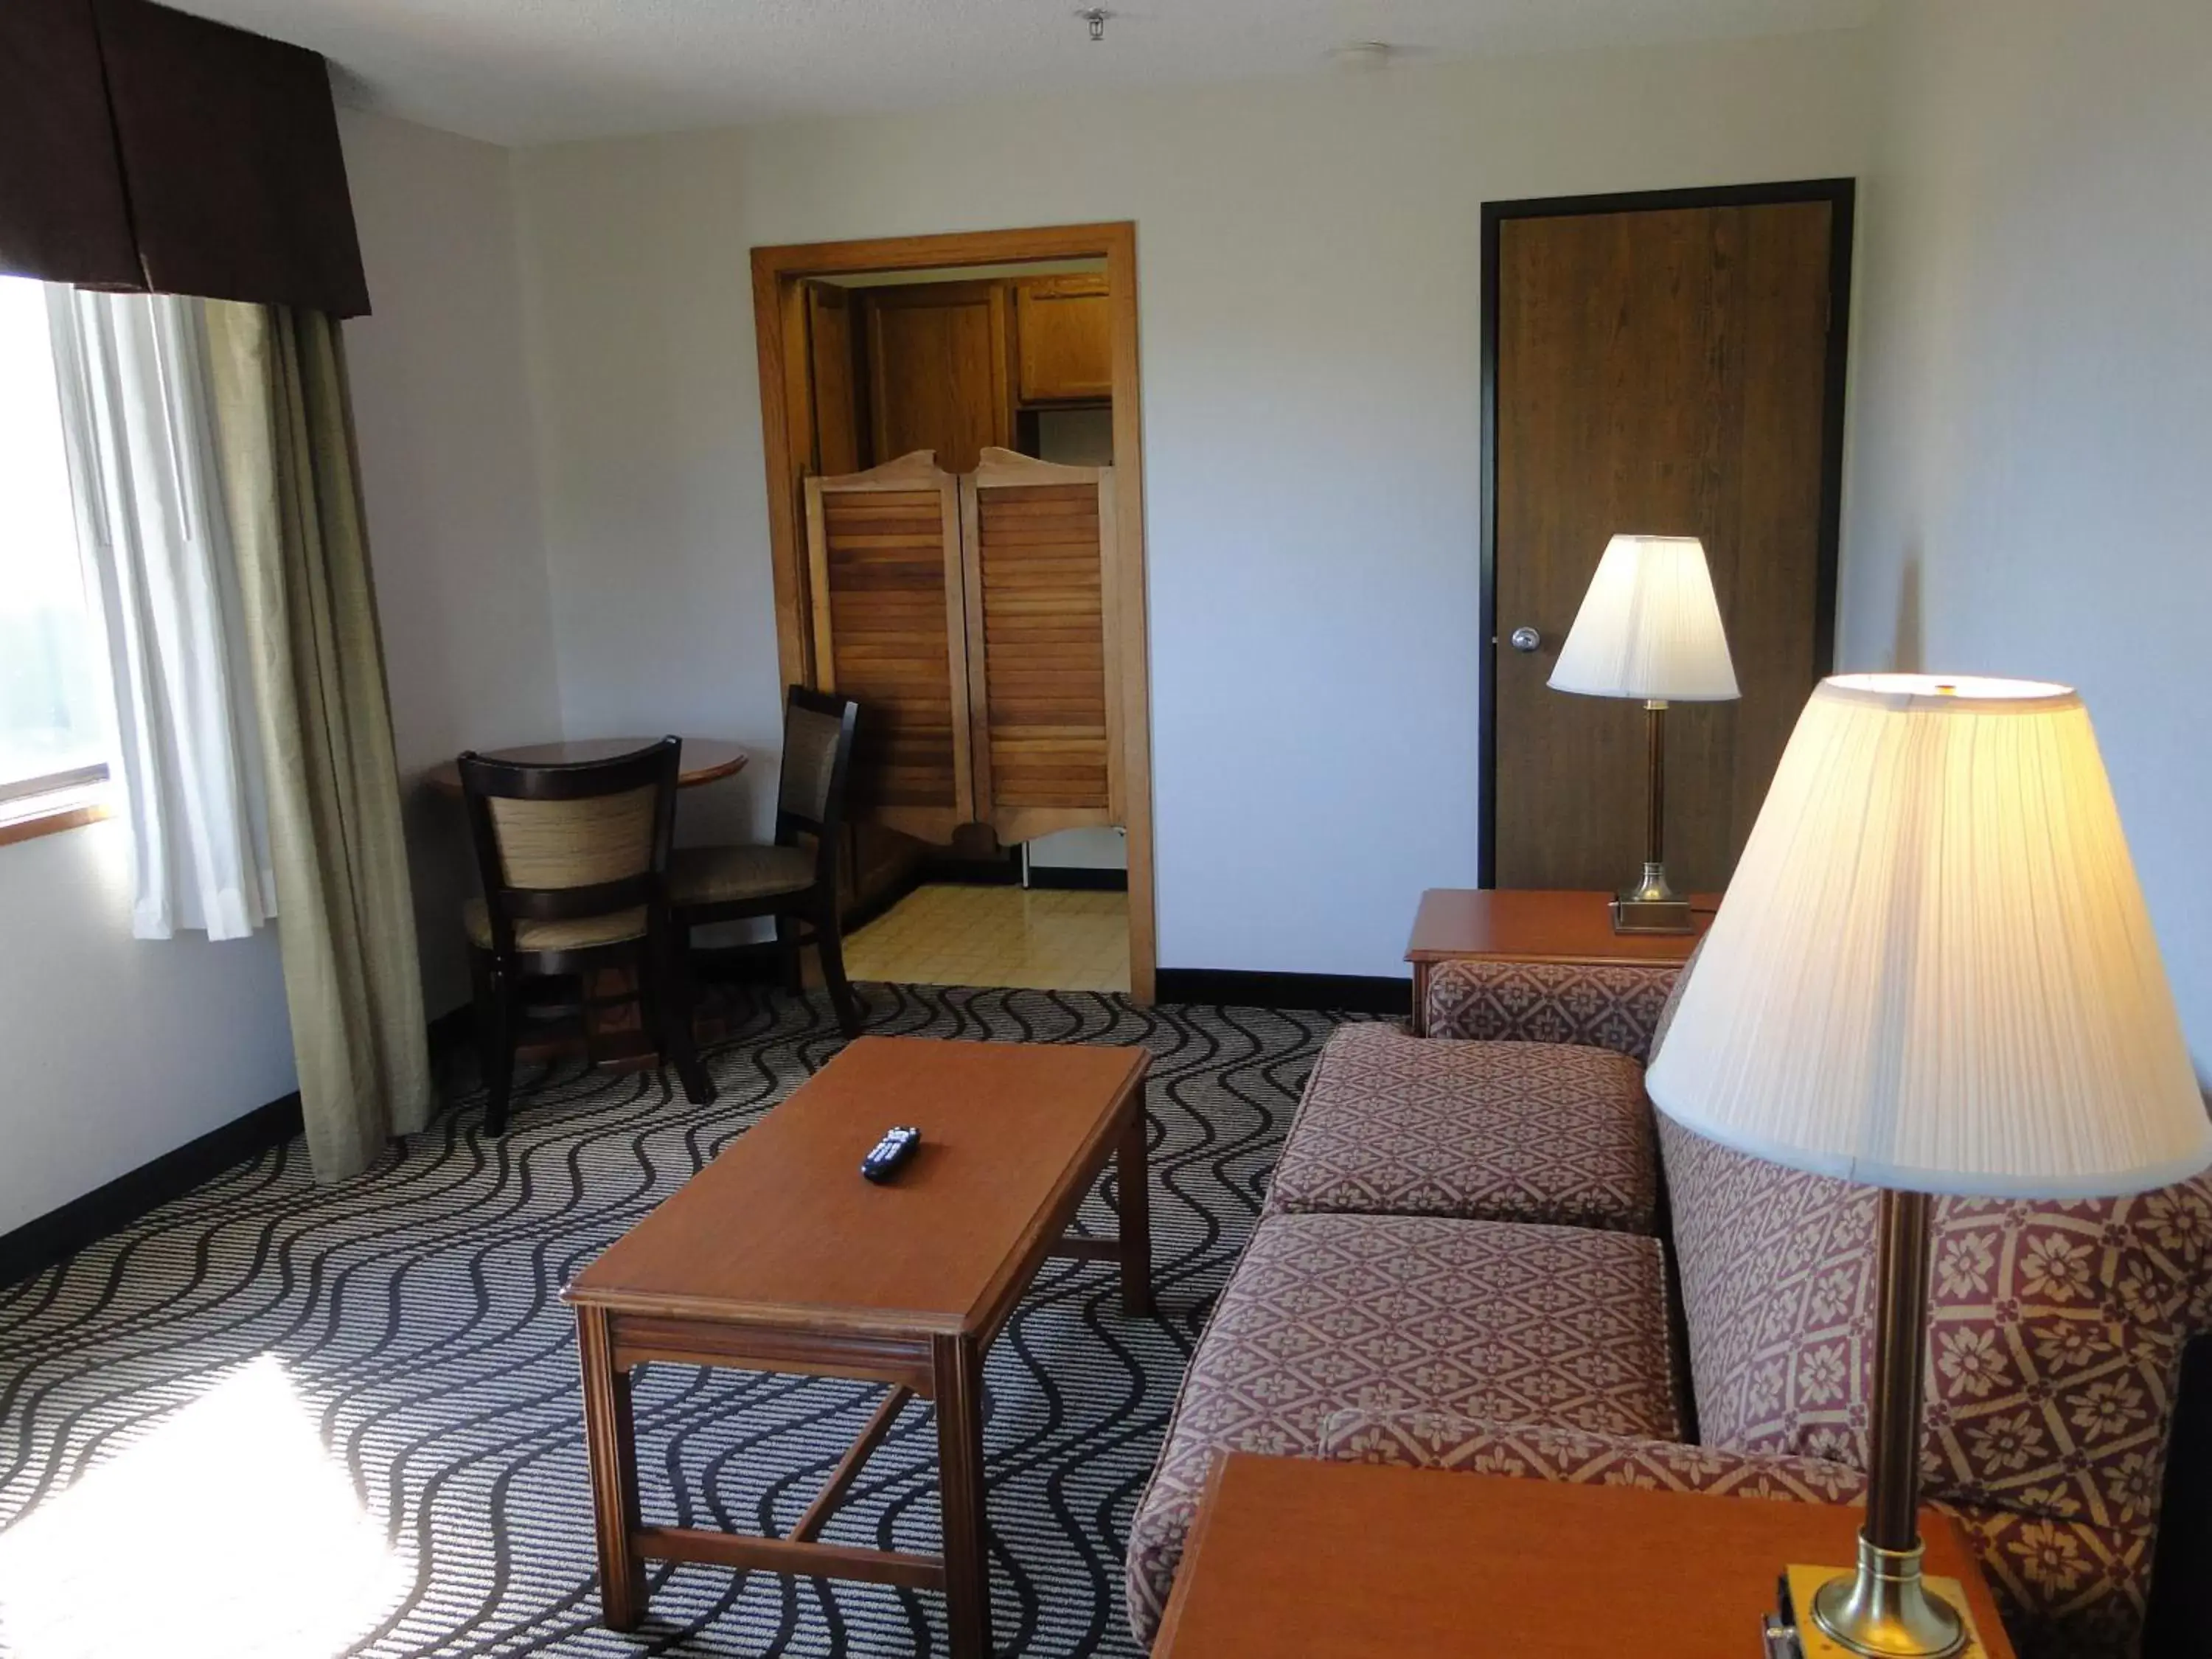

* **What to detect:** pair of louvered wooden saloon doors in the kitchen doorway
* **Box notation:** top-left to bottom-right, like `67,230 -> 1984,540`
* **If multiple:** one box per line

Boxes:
805,447 -> 1126,845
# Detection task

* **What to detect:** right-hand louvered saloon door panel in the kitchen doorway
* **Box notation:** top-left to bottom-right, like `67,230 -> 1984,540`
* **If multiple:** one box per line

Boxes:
960,449 -> 1124,843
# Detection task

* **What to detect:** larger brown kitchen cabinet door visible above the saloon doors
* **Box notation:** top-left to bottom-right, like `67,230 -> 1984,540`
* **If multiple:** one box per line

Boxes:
863,281 -> 1013,473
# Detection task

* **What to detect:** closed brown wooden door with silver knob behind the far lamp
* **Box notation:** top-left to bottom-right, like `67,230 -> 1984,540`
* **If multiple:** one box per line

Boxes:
1489,199 -> 1845,891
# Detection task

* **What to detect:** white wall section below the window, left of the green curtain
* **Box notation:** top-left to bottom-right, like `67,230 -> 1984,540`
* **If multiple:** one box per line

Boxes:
0,823 -> 299,1232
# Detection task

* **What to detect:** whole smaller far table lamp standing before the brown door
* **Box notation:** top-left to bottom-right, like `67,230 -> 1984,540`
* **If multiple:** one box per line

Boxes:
1548,535 -> 1741,933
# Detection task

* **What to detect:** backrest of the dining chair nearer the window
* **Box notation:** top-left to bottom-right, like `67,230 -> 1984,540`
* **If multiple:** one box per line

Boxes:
460,737 -> 684,956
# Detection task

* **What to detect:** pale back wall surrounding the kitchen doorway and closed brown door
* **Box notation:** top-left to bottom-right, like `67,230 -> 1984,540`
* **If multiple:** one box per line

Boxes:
520,35 -> 1869,973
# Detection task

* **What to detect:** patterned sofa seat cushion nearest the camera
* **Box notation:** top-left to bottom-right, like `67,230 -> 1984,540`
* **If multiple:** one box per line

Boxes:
1128,1214 -> 1681,1641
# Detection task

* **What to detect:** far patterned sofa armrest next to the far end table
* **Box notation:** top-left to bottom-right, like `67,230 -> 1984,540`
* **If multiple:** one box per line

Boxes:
1422,958 -> 1679,1062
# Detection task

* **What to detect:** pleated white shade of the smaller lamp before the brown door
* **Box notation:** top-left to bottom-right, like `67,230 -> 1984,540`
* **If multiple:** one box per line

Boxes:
1548,535 -> 1739,703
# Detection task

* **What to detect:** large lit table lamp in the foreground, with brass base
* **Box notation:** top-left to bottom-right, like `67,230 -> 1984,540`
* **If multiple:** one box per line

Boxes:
1646,675 -> 2212,1659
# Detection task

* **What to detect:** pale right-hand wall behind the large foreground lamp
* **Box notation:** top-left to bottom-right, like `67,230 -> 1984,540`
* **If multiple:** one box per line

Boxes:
1838,0 -> 2212,1071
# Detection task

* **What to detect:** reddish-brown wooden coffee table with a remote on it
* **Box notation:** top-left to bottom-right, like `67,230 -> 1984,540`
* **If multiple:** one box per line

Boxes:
562,1037 -> 1152,1659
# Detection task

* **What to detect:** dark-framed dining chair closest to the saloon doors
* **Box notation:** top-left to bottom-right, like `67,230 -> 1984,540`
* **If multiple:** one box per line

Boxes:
668,686 -> 860,1037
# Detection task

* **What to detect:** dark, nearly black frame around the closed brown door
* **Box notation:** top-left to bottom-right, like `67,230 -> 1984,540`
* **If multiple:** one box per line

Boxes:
1475,179 -> 1858,887
